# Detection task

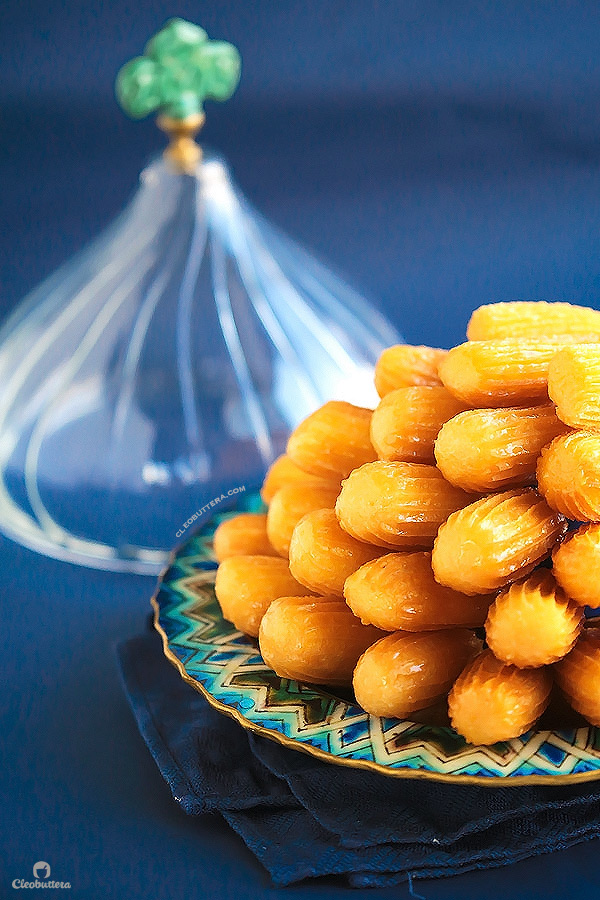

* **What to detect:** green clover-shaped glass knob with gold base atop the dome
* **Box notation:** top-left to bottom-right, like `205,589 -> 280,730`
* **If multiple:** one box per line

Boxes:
116,19 -> 241,171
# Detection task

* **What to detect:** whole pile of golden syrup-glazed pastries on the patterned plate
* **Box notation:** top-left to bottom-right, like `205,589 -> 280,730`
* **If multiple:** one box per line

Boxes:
214,301 -> 600,744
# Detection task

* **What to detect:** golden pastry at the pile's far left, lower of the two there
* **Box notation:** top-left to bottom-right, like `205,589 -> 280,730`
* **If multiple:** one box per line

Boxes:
215,556 -> 306,637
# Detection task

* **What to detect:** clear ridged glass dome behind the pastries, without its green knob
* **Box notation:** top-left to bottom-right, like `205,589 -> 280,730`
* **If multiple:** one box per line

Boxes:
0,156 -> 399,573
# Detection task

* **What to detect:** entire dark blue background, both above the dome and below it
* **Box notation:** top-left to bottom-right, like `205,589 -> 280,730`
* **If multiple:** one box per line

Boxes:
0,0 -> 600,900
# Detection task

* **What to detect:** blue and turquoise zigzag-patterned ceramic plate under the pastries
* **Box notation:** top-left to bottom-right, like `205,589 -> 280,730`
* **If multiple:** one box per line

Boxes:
152,495 -> 600,787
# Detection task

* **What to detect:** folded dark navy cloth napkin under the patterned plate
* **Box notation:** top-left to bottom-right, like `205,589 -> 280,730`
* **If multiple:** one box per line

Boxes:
118,633 -> 600,890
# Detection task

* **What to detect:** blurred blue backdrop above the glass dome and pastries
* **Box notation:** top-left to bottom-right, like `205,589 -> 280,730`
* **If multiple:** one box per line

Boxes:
0,0 -> 600,345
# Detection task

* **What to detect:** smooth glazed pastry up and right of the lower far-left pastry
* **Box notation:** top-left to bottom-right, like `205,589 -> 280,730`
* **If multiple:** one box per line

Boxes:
290,509 -> 384,597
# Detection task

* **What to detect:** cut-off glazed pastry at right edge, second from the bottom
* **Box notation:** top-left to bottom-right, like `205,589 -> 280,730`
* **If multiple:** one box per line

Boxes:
552,525 -> 600,609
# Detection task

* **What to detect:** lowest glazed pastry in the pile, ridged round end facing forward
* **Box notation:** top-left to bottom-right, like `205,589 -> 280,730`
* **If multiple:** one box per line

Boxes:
448,650 -> 552,744
